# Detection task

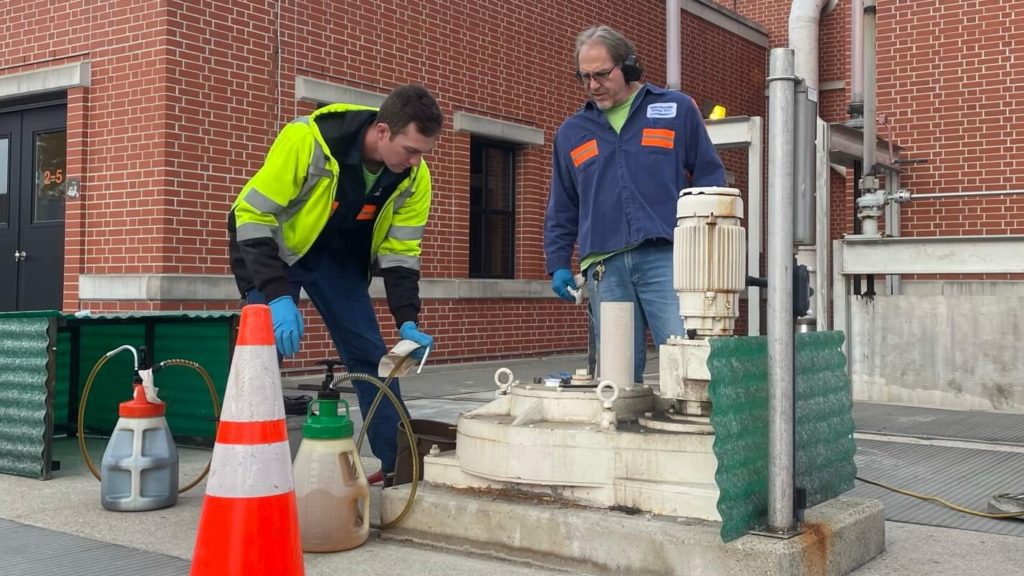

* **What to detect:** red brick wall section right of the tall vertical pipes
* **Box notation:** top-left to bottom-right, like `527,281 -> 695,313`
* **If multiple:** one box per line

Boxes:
879,0 -> 1024,236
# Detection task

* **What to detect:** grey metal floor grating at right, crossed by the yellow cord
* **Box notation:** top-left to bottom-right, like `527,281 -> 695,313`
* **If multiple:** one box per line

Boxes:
850,440 -> 1024,536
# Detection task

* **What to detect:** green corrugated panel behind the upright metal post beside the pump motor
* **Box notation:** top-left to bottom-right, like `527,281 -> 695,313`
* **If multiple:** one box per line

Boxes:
708,332 -> 856,542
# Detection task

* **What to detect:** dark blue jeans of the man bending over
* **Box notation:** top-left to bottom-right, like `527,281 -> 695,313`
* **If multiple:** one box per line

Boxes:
247,248 -> 409,474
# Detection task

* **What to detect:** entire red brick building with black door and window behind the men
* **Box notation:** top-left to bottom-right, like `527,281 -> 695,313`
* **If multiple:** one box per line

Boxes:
0,0 -> 1024,366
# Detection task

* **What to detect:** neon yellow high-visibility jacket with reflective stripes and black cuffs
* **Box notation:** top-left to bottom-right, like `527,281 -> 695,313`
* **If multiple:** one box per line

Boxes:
228,104 -> 431,325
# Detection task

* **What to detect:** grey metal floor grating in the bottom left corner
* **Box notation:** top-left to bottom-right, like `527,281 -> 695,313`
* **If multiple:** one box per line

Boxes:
0,520 -> 189,576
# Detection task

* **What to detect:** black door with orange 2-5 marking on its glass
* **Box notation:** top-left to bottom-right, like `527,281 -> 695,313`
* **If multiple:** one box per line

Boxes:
0,106 -> 68,312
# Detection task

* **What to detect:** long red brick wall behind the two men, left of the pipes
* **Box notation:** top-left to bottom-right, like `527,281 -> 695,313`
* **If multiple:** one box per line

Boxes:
0,0 -> 765,366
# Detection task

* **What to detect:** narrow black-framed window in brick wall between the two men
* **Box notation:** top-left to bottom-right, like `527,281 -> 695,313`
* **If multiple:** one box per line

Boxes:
469,137 -> 516,278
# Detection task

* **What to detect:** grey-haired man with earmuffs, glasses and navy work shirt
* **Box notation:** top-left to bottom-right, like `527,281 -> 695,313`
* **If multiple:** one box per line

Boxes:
544,26 -> 725,384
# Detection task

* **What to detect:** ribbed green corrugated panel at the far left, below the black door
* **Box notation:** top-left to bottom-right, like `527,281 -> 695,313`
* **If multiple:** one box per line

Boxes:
0,314 -> 52,478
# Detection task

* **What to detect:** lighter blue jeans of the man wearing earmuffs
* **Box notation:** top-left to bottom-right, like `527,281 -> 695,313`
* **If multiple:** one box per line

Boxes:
587,242 -> 683,382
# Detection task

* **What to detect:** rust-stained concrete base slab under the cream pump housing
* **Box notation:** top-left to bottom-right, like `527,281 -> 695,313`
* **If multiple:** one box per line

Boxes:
381,483 -> 885,576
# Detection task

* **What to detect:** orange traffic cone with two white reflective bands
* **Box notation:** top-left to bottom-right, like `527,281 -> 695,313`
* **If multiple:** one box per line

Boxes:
190,304 -> 303,576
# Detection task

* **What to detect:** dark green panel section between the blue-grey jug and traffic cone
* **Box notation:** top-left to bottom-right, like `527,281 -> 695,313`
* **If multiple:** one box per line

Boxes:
155,322 -> 231,446
